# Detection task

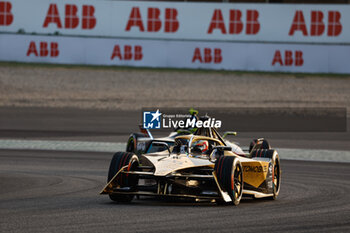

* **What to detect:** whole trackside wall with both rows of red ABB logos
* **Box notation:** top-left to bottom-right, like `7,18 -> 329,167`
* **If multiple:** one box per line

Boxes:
0,0 -> 350,74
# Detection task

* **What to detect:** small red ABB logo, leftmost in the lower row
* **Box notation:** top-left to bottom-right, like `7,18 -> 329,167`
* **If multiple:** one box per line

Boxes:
27,41 -> 60,57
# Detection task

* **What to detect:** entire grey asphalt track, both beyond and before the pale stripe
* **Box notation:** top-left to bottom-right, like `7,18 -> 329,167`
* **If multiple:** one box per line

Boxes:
0,108 -> 350,232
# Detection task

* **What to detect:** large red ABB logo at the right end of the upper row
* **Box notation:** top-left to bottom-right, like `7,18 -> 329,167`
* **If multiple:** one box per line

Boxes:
289,11 -> 342,36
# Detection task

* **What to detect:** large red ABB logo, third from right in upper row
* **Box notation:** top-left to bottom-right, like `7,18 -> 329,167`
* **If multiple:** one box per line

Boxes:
125,7 -> 180,33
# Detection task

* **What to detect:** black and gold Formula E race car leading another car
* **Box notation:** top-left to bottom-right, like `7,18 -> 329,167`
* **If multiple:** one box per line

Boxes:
101,128 -> 281,205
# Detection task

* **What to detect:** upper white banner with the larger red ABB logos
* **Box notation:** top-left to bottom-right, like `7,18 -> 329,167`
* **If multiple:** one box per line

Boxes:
0,0 -> 350,43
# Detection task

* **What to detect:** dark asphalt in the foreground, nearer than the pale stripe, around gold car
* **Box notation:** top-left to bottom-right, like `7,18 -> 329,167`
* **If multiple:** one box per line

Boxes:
0,150 -> 350,232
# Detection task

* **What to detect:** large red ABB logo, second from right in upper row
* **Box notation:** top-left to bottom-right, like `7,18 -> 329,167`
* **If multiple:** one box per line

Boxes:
208,9 -> 260,35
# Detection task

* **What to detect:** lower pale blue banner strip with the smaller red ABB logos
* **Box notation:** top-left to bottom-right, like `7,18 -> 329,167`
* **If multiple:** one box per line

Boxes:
0,34 -> 350,74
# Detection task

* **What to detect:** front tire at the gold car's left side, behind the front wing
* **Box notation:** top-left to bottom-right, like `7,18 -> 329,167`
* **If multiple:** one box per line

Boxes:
107,152 -> 139,202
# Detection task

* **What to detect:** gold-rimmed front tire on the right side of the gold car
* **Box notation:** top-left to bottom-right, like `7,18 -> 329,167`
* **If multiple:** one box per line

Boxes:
214,156 -> 243,205
